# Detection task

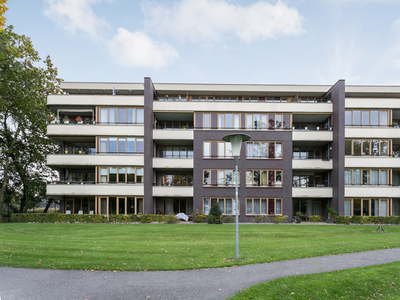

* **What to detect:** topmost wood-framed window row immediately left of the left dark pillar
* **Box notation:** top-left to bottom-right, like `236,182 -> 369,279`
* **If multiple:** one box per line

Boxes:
99,107 -> 143,124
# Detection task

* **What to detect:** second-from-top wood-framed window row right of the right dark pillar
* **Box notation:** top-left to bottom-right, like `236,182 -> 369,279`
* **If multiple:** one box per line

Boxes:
345,140 -> 392,156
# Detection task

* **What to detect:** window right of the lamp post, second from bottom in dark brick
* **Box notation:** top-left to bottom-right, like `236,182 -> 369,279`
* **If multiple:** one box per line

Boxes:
246,170 -> 282,187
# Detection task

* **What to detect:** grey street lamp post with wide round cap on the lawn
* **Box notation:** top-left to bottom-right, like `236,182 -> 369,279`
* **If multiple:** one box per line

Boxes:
222,134 -> 250,261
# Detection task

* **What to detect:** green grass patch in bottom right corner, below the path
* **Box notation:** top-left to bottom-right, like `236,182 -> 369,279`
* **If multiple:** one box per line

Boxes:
229,262 -> 400,300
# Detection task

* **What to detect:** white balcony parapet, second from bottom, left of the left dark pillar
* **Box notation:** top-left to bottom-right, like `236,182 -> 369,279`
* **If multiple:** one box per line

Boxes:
47,154 -> 144,166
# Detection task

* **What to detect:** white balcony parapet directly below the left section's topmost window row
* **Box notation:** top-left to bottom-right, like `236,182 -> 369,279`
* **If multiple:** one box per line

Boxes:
47,124 -> 144,139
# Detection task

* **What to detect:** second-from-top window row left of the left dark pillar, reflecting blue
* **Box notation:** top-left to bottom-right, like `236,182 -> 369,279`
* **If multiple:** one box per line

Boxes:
99,137 -> 143,154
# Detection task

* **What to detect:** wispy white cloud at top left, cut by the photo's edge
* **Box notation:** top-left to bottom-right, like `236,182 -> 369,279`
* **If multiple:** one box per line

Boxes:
44,0 -> 110,40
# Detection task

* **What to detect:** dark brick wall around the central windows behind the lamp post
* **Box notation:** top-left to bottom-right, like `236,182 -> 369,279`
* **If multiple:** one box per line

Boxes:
193,130 -> 292,222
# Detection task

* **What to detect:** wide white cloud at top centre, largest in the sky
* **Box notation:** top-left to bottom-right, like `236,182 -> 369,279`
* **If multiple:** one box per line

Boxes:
142,0 -> 305,42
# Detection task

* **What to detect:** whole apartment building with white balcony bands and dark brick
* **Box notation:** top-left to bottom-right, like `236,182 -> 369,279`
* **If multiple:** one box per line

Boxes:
47,78 -> 400,222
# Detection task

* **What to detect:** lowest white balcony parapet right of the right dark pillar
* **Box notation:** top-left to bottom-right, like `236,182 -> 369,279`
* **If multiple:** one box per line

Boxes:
344,185 -> 400,198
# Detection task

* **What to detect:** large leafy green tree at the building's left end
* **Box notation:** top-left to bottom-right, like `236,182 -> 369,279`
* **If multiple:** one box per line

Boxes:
0,24 -> 61,222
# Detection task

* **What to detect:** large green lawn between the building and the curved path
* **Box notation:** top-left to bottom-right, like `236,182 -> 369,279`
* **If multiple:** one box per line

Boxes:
0,223 -> 400,271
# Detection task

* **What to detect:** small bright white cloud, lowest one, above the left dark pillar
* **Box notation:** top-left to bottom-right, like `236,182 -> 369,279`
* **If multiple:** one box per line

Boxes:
108,28 -> 179,69
